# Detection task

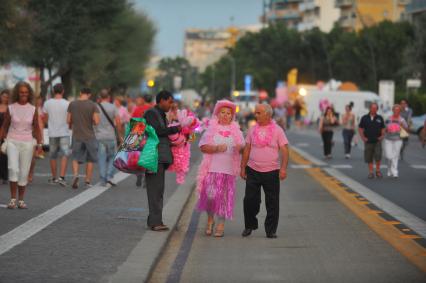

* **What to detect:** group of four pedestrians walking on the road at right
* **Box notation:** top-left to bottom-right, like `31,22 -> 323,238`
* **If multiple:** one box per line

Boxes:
318,99 -> 420,179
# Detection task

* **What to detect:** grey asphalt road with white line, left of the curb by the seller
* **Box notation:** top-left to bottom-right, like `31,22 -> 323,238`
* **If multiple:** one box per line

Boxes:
0,145 -> 200,283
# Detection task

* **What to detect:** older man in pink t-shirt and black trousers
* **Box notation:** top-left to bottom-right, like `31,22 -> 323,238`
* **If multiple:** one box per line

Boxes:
241,104 -> 288,238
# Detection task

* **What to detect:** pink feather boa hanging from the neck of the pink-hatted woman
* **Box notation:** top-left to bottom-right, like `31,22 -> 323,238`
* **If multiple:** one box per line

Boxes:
197,118 -> 244,193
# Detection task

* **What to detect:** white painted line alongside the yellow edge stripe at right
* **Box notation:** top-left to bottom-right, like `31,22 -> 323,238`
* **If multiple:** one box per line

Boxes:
292,146 -> 426,238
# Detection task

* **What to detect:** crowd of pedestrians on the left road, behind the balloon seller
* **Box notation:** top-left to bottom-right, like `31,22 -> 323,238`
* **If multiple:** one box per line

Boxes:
0,82 -> 156,209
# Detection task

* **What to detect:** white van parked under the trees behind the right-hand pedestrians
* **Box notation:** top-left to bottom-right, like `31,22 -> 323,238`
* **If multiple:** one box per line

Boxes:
303,90 -> 382,122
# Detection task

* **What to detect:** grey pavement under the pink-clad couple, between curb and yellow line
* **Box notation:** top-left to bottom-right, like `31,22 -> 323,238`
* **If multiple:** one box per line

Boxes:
150,163 -> 426,283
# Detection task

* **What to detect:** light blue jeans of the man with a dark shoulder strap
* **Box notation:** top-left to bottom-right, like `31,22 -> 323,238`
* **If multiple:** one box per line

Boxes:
98,140 -> 116,183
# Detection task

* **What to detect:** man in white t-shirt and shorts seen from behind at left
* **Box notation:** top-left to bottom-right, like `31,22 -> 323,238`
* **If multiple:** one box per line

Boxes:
43,84 -> 71,187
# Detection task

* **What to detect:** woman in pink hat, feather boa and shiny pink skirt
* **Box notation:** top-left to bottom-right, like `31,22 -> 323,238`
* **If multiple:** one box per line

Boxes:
197,100 -> 244,237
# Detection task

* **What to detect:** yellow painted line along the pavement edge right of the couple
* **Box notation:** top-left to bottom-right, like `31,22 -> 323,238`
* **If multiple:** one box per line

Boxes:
290,148 -> 426,272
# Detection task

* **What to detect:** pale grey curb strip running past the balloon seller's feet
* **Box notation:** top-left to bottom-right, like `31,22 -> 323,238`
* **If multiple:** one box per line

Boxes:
108,158 -> 202,283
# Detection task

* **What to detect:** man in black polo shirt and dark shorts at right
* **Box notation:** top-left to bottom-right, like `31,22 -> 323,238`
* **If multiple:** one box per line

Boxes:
358,103 -> 385,179
